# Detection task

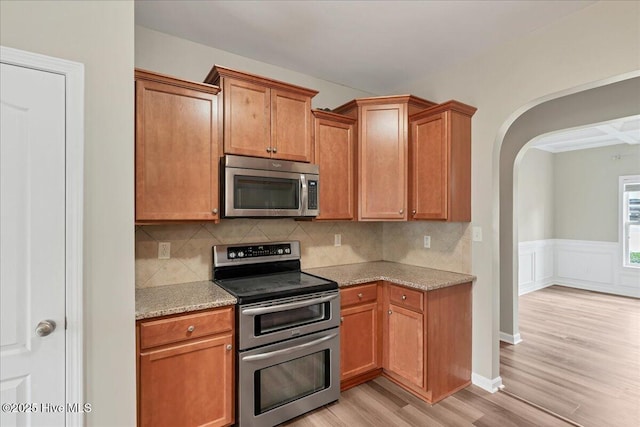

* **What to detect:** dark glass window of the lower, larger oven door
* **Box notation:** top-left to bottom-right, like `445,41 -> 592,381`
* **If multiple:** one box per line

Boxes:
254,350 -> 330,415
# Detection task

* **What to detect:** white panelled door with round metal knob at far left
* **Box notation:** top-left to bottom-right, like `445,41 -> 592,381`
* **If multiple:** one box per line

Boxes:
0,63 -> 66,426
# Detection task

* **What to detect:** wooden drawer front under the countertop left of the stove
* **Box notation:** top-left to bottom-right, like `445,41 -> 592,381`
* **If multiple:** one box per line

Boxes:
140,307 -> 234,349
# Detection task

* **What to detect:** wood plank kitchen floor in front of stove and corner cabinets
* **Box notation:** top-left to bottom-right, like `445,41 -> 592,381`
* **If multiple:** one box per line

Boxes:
283,377 -> 570,427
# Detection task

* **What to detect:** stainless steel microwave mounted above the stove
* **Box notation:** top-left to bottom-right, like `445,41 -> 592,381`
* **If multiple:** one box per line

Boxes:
222,155 -> 320,218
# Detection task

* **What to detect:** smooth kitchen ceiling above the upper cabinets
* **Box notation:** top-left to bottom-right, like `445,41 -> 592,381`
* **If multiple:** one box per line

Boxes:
135,0 -> 595,95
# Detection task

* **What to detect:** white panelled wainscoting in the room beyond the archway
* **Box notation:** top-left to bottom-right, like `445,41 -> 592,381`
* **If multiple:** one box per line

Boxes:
516,239 -> 640,298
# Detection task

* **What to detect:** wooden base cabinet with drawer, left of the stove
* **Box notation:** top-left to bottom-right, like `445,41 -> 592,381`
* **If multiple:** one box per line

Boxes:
138,307 -> 234,427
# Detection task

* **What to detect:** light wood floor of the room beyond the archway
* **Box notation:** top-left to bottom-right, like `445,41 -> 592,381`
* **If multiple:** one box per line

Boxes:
500,286 -> 640,427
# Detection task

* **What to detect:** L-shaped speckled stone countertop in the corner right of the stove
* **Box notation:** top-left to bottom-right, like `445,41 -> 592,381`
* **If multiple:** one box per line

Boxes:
304,261 -> 476,291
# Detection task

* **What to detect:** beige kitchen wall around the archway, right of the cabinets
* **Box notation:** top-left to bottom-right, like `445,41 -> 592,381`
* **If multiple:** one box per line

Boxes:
396,1 -> 640,384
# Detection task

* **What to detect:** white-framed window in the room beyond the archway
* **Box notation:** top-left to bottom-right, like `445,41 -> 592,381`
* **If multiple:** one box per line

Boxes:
620,175 -> 640,268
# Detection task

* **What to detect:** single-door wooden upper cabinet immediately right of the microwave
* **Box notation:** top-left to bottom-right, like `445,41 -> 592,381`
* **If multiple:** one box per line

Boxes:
313,110 -> 356,220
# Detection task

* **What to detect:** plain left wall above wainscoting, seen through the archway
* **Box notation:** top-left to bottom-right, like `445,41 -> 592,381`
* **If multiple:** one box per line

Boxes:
515,148 -> 555,242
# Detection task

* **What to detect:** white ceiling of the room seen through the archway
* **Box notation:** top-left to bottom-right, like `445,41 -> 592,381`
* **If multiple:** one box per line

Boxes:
531,115 -> 640,153
